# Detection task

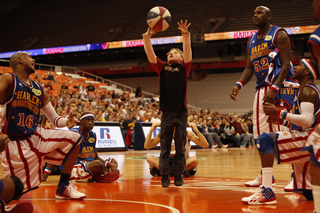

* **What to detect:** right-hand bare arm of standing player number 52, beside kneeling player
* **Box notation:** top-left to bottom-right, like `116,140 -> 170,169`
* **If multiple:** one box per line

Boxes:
264,30 -> 291,103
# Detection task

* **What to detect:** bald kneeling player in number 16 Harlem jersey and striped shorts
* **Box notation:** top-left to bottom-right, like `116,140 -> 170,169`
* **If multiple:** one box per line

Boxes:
0,52 -> 86,199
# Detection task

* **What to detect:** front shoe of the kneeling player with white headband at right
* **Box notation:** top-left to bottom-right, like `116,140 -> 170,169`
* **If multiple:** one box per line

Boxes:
241,186 -> 277,205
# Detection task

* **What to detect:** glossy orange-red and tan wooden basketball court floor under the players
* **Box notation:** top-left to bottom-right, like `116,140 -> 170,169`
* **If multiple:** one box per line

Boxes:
10,148 -> 313,213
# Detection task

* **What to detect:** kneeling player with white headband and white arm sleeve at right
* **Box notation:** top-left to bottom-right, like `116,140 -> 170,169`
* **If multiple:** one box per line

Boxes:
242,59 -> 320,205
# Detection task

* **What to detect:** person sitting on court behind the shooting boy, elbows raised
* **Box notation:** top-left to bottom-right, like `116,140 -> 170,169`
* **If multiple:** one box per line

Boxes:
144,122 -> 209,177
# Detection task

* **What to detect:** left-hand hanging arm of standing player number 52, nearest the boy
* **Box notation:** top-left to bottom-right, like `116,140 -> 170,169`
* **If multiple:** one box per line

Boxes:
230,40 -> 254,101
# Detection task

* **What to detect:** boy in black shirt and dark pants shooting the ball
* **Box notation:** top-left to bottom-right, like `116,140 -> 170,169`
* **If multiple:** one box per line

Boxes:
142,11 -> 192,187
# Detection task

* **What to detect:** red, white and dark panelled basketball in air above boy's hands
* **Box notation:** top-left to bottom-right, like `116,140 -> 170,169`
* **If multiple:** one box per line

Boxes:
147,6 -> 171,32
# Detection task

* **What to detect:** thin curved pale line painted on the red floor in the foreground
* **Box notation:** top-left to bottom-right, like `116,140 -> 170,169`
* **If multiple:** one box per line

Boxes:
20,198 -> 180,213
